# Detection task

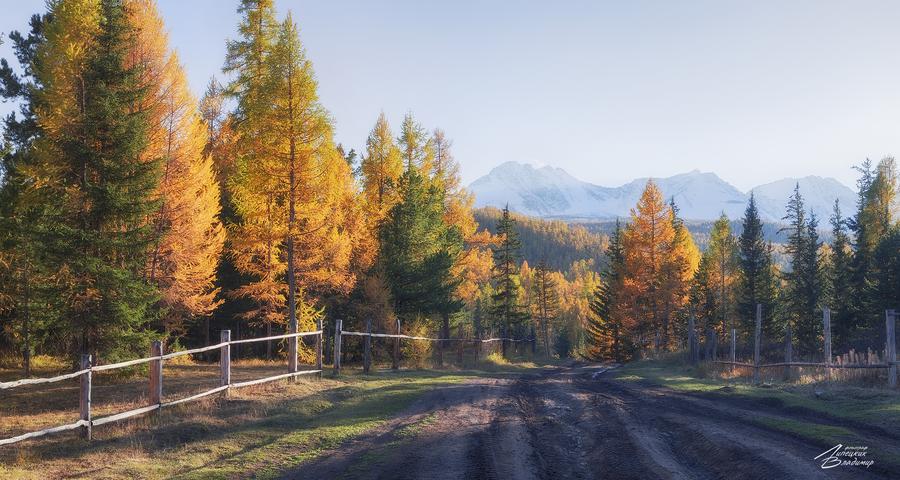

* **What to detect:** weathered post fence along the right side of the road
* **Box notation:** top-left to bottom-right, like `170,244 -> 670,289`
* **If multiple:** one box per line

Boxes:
688,305 -> 900,388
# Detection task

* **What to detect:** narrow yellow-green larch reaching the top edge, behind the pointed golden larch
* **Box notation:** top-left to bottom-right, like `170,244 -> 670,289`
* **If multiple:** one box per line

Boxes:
223,0 -> 287,357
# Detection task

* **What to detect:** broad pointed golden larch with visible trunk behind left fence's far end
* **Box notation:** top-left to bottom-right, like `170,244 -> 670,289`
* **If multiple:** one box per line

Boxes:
231,12 -> 361,358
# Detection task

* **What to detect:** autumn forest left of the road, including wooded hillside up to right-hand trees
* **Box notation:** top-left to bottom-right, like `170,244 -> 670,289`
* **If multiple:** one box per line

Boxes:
0,0 -> 605,374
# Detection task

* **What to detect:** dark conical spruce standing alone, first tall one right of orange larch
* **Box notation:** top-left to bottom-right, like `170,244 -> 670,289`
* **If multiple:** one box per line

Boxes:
735,192 -> 775,338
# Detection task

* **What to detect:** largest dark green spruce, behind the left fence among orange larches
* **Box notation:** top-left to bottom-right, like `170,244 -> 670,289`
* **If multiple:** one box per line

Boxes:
43,0 -> 163,360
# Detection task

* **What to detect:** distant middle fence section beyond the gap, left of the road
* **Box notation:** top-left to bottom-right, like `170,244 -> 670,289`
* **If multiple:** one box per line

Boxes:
334,320 -> 536,374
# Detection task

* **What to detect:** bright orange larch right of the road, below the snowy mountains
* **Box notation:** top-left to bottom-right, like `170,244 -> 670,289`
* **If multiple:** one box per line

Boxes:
623,180 -> 675,346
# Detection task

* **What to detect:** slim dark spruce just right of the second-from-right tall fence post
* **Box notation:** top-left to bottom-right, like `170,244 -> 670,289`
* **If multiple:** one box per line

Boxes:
825,200 -> 858,348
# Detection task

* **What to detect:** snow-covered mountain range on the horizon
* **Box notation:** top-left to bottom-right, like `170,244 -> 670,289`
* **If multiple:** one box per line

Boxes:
469,162 -> 855,221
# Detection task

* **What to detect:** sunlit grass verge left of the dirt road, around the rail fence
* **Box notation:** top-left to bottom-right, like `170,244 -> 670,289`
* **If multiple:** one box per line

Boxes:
0,362 -> 534,479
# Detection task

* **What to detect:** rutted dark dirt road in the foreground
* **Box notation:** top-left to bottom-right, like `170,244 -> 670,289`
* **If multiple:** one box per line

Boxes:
285,366 -> 900,479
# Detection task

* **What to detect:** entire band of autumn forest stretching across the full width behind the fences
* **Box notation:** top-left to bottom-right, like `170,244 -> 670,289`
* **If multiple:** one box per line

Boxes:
0,0 -> 900,374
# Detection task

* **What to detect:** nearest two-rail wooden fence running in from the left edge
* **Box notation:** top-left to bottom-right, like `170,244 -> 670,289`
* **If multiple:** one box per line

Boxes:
0,321 -> 322,446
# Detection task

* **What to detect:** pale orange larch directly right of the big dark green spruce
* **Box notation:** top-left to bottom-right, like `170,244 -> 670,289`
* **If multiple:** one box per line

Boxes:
126,0 -> 225,334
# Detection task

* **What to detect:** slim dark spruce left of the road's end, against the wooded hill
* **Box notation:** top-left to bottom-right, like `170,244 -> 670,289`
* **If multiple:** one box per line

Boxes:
491,206 -> 528,356
